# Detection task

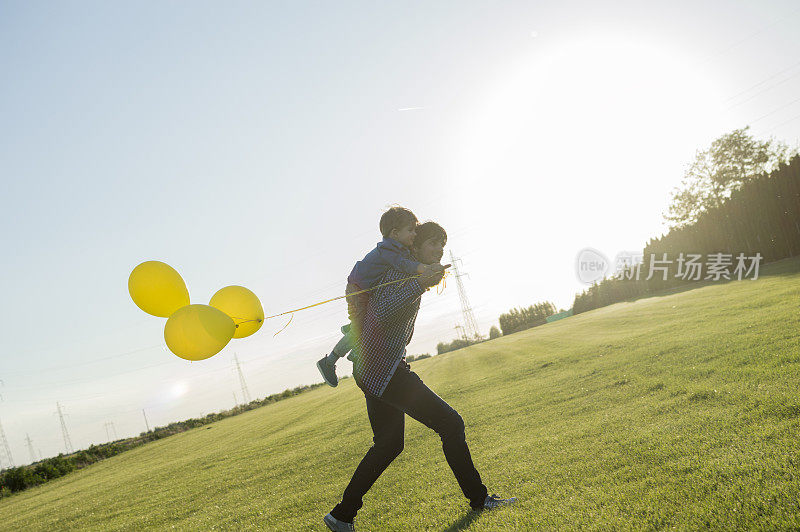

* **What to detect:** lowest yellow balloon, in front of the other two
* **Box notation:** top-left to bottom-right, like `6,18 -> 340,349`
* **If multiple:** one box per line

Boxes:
164,305 -> 236,360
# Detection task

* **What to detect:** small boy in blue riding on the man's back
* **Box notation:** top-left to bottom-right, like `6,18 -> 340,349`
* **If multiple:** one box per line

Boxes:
317,206 -> 444,387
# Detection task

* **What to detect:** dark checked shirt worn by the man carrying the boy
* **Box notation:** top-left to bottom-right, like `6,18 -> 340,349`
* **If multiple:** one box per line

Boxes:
353,269 -> 426,397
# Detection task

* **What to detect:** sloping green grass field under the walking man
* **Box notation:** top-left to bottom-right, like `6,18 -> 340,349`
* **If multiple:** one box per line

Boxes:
0,260 -> 800,531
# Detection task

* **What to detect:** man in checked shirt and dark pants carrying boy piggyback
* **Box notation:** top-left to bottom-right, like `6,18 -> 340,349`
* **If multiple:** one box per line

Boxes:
324,222 -> 516,532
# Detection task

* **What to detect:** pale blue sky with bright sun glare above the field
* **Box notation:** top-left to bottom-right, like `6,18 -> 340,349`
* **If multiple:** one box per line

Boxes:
0,0 -> 800,467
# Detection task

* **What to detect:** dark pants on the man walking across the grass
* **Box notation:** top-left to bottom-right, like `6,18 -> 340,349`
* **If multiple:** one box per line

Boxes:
331,360 -> 487,522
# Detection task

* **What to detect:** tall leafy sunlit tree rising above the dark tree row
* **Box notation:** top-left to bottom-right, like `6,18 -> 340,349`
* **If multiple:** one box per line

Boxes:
664,126 -> 794,228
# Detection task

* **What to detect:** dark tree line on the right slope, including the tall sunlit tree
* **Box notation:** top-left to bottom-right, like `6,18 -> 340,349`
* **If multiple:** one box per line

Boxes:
573,128 -> 800,314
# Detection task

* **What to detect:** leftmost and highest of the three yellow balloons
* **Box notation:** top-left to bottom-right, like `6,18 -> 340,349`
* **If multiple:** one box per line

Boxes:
128,260 -> 189,318
